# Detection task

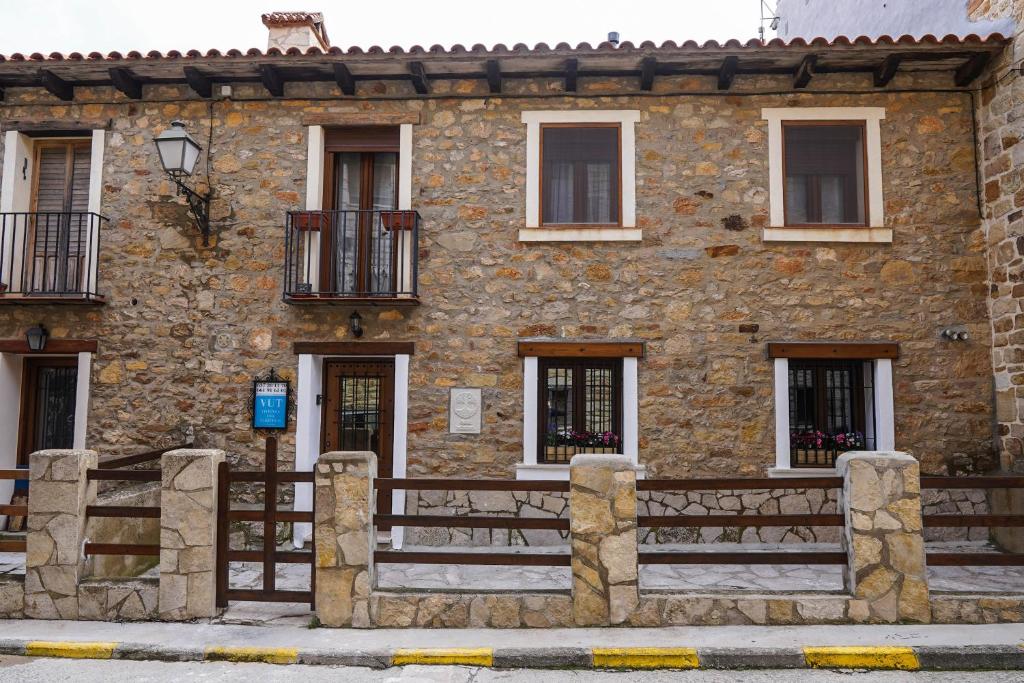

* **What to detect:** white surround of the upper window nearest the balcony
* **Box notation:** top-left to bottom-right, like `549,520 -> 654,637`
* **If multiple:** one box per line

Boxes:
519,110 -> 643,242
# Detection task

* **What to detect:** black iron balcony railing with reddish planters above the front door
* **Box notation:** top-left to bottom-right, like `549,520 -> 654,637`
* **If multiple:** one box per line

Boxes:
285,210 -> 420,306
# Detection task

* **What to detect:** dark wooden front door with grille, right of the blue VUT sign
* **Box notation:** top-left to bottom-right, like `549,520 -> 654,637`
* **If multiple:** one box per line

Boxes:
321,358 -> 394,514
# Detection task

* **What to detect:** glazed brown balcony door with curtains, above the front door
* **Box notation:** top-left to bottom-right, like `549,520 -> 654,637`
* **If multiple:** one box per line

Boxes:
321,127 -> 398,296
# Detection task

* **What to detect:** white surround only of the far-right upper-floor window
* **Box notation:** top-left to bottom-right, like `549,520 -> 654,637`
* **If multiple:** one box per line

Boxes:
761,106 -> 893,244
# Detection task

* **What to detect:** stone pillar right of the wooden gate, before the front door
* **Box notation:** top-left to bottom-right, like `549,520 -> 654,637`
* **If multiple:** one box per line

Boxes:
313,451 -> 377,628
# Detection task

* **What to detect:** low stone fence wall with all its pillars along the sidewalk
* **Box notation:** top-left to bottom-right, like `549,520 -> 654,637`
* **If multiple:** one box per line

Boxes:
0,450 -> 1024,628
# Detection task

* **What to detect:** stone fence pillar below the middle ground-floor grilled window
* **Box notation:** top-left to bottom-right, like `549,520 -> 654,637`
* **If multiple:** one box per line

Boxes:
569,455 -> 640,626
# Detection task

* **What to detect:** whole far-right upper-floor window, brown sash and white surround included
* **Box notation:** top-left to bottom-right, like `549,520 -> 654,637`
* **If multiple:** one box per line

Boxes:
762,106 -> 892,242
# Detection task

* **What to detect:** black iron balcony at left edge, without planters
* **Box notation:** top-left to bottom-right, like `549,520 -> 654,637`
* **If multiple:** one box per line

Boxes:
0,211 -> 106,304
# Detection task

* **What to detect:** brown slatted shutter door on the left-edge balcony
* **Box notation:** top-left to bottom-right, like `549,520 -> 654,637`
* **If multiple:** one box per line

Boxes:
25,140 -> 91,294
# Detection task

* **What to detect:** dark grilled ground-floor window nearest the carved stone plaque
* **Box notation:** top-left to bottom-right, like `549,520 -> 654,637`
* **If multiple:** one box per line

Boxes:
538,358 -> 623,464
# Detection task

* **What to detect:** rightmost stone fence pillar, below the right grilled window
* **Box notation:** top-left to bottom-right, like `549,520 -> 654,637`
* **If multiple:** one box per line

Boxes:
836,452 -> 932,624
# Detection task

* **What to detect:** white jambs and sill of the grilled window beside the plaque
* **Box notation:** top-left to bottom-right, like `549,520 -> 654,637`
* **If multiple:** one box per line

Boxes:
520,355 -> 640,481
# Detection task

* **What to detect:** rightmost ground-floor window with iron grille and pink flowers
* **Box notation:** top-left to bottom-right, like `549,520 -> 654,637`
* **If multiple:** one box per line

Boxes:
790,359 -> 876,468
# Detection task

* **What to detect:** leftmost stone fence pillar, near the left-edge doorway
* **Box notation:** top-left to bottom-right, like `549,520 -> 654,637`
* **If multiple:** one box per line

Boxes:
25,450 -> 96,618
